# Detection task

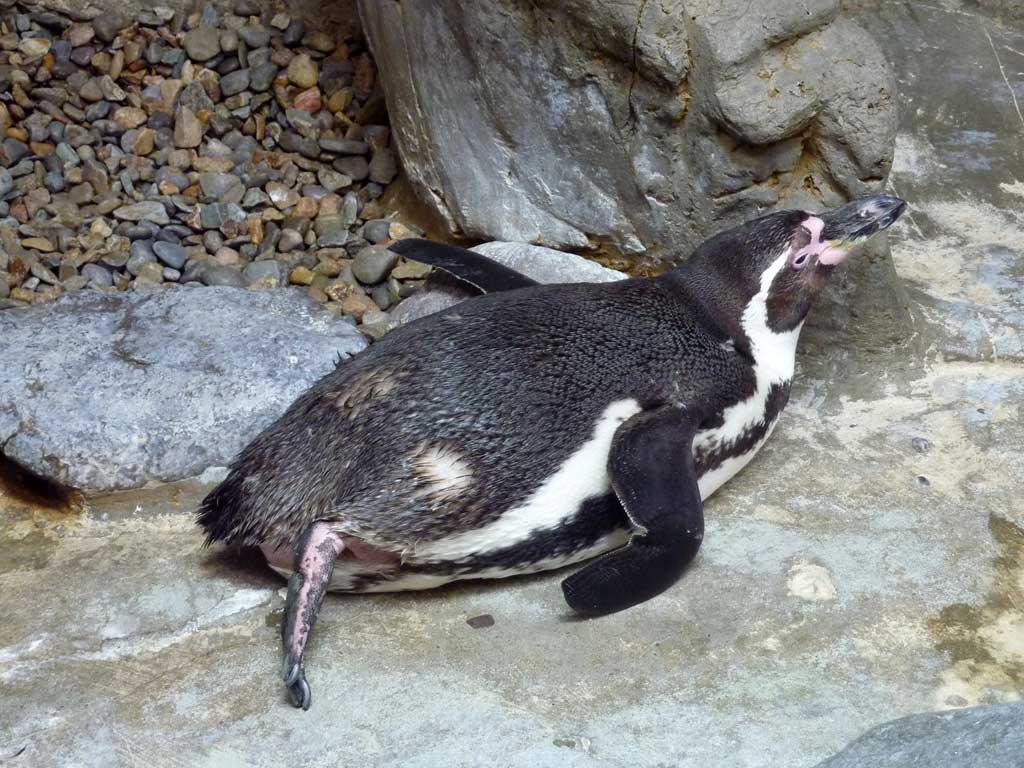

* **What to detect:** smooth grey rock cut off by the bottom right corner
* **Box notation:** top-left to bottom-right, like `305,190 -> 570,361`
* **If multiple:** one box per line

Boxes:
817,701 -> 1024,768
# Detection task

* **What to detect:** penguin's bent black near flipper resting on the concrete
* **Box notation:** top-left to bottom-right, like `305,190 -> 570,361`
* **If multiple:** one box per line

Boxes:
562,407 -> 703,616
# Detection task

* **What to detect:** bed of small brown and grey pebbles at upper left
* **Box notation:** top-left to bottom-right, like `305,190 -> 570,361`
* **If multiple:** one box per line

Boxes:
0,0 -> 429,337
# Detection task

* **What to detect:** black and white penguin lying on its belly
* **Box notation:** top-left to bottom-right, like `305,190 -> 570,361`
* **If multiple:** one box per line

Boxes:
198,196 -> 905,710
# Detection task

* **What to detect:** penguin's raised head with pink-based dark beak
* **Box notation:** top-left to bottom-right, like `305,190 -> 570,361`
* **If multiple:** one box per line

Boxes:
688,195 -> 906,337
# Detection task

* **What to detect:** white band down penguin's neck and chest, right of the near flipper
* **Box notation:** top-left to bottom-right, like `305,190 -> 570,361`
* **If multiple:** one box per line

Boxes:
693,250 -> 803,499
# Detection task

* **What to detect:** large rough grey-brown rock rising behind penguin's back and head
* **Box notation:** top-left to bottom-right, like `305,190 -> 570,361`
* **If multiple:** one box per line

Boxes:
359,0 -> 896,258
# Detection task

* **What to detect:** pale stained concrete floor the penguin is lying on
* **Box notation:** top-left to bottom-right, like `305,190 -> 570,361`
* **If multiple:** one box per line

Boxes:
0,0 -> 1024,768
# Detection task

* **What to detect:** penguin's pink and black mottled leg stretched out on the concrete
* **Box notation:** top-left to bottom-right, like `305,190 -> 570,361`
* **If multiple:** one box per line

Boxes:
281,522 -> 345,710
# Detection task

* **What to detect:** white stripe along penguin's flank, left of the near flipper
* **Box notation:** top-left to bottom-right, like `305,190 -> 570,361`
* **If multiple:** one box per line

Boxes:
403,399 -> 641,562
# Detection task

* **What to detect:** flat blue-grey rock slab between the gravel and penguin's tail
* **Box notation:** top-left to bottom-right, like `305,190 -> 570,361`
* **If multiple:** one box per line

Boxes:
0,288 -> 366,490
